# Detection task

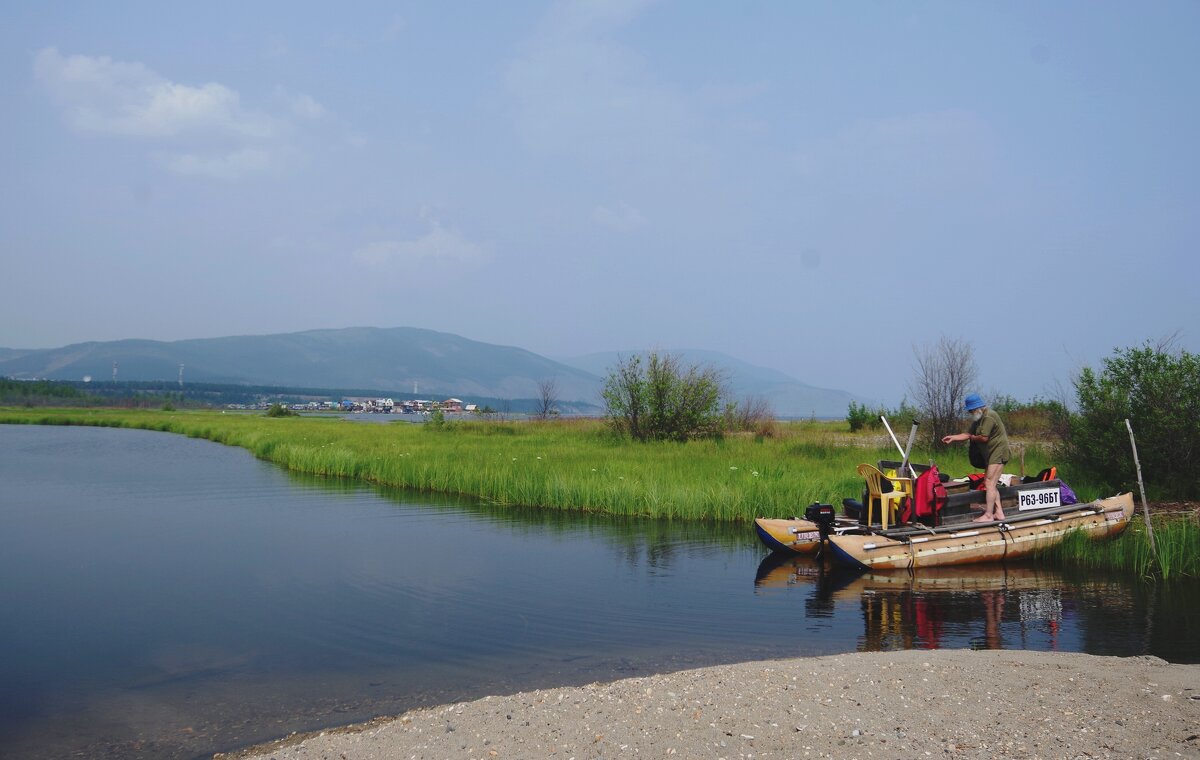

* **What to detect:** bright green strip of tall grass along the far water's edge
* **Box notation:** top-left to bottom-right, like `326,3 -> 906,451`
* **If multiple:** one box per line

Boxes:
0,409 -> 1070,522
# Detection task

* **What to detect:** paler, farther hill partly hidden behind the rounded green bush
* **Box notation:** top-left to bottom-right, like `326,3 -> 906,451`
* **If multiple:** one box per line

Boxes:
558,348 -> 868,418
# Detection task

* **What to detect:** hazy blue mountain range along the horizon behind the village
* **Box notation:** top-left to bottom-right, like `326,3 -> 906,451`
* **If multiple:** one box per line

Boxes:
0,328 -> 862,417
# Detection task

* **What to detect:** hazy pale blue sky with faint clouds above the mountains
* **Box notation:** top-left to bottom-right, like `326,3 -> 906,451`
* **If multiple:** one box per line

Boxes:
0,0 -> 1200,403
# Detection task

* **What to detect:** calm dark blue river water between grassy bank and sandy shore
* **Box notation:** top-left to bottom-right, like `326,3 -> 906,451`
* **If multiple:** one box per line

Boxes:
0,426 -> 1200,758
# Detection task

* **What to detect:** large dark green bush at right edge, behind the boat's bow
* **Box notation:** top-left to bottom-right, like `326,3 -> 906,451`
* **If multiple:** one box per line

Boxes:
1067,341 -> 1200,498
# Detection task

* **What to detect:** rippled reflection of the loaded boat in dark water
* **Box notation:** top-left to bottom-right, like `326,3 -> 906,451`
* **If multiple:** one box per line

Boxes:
755,553 -> 1153,654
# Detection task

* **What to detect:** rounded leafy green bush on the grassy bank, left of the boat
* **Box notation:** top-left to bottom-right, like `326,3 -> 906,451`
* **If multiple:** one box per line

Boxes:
601,351 -> 725,441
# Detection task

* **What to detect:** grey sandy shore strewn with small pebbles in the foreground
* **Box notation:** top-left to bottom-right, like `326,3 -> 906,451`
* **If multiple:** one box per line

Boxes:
226,650 -> 1200,760
